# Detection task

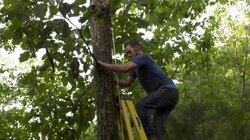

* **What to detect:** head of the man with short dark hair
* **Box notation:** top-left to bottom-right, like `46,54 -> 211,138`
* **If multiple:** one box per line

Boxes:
124,39 -> 142,56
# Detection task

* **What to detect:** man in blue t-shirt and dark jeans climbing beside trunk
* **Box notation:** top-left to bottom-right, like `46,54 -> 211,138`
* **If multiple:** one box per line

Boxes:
98,40 -> 178,140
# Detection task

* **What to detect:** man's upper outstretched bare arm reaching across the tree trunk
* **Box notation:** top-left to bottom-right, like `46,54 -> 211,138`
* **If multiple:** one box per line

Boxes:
97,60 -> 137,73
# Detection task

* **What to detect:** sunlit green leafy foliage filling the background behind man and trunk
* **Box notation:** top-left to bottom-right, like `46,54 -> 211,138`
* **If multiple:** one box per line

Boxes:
0,0 -> 250,140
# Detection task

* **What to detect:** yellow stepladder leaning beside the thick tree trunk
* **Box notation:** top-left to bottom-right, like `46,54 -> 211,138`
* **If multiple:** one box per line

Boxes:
118,93 -> 147,140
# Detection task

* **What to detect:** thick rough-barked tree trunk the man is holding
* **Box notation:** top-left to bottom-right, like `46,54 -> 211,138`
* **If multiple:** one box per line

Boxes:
90,0 -> 118,140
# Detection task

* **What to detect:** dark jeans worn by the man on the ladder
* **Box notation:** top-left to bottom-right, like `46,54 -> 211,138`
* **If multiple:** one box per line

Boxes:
136,87 -> 179,140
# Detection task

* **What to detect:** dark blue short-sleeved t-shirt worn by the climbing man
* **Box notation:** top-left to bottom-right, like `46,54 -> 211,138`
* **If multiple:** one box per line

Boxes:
129,54 -> 176,93
